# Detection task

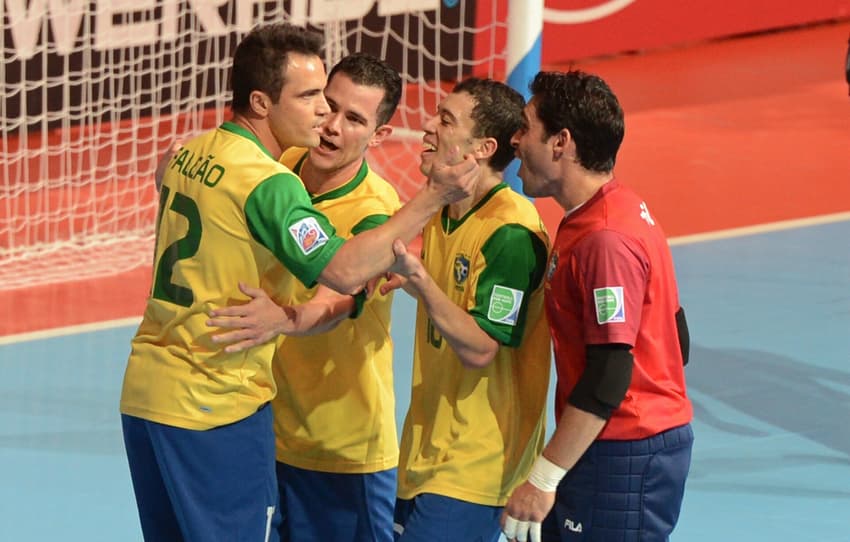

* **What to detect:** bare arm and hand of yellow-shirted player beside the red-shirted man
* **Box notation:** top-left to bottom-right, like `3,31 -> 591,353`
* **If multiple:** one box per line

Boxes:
390,240 -> 499,369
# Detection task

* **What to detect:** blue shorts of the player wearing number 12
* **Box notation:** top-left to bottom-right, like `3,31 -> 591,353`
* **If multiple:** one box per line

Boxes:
121,405 -> 280,542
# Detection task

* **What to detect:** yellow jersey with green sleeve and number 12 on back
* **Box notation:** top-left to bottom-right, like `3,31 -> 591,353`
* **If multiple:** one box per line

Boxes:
121,122 -> 343,430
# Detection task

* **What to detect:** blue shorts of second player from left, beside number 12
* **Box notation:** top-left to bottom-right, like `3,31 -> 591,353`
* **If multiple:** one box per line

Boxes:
277,462 -> 397,542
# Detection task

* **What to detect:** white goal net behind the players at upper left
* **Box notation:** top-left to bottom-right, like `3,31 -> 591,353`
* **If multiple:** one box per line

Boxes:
0,0 -> 505,290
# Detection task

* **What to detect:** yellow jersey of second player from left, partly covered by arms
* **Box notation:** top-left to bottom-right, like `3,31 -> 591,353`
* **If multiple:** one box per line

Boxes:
272,149 -> 400,473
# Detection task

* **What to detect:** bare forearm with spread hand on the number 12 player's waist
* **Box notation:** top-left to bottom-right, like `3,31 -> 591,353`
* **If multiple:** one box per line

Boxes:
207,283 -> 354,352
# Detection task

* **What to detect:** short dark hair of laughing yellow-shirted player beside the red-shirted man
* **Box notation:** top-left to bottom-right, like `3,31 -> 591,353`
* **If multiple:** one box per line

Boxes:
452,77 -> 525,171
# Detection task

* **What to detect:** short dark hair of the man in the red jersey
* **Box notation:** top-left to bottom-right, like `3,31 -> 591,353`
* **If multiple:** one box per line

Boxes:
530,70 -> 625,173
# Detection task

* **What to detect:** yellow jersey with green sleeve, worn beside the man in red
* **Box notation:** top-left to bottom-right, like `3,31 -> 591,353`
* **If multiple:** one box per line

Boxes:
398,184 -> 550,506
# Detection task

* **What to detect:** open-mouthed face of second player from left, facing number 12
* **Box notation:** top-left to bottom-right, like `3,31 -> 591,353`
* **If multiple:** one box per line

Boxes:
310,72 -> 384,173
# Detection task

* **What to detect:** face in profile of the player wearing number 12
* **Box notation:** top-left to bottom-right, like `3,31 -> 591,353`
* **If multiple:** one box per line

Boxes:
268,53 -> 329,149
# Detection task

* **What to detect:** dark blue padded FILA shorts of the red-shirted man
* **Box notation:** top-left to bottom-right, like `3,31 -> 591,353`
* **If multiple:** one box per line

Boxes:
542,424 -> 694,542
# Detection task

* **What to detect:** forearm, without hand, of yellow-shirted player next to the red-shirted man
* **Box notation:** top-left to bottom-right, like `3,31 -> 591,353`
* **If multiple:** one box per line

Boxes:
407,272 -> 499,369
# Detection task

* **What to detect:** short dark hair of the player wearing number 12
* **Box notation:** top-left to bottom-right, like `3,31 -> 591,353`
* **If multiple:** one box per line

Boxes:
230,23 -> 324,111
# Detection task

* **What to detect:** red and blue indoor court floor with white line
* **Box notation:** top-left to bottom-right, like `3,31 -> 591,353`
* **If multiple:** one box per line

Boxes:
0,21 -> 850,542
